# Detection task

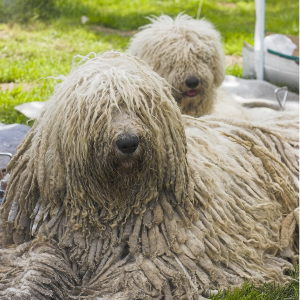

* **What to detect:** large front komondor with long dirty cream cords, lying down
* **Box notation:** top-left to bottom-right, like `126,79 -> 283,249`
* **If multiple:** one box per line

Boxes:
0,52 -> 298,300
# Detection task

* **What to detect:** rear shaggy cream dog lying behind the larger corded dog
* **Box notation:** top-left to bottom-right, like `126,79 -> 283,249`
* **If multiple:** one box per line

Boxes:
127,14 -> 299,121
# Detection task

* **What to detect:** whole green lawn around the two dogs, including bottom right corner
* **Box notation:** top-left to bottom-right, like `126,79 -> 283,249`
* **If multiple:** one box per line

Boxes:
0,0 -> 299,300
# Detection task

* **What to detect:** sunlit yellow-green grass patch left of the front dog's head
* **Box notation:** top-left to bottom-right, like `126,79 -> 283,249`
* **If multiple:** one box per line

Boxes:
0,22 -> 129,125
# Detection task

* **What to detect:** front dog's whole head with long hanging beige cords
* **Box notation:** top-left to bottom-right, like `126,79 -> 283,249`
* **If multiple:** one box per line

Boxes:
2,52 -> 188,225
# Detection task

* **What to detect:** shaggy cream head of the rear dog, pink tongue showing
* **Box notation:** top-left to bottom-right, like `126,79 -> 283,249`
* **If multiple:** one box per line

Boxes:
128,15 -> 225,116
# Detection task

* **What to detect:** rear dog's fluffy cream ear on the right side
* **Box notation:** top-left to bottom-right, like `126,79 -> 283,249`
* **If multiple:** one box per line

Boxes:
212,40 -> 226,87
